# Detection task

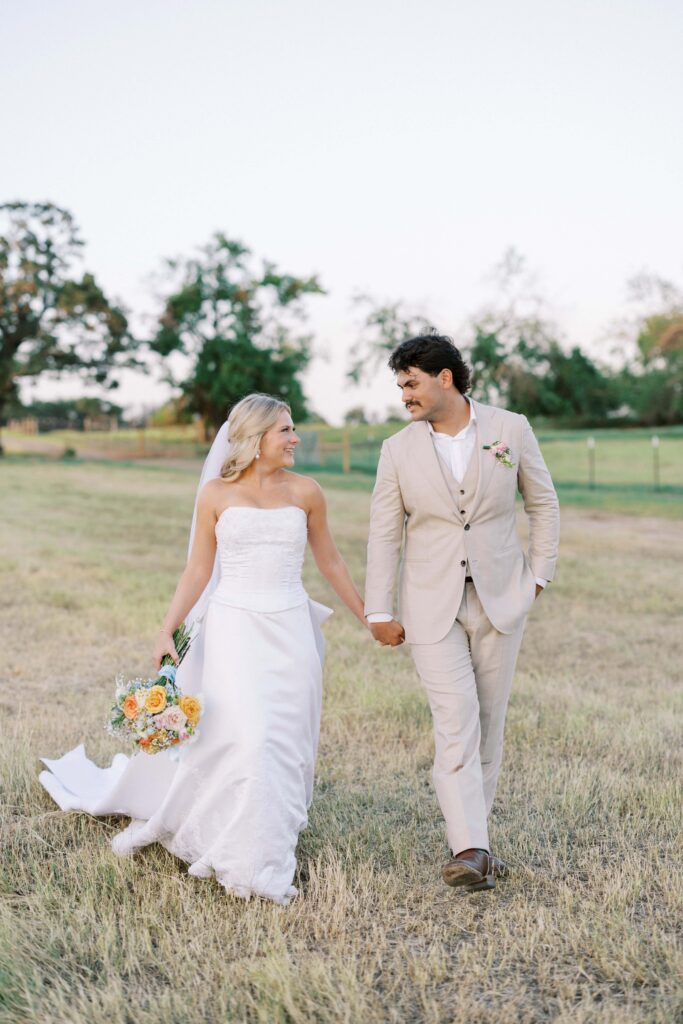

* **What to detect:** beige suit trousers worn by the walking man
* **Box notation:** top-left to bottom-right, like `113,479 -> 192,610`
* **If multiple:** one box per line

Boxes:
411,583 -> 524,854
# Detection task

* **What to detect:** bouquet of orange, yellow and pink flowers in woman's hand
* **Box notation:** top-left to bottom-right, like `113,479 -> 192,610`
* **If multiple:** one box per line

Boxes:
106,623 -> 202,754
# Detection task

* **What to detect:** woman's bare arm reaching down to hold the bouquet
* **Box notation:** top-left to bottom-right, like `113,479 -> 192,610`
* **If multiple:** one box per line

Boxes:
154,483 -> 216,671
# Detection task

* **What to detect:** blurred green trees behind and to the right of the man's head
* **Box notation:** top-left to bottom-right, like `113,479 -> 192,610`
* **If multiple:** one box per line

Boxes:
349,264 -> 683,427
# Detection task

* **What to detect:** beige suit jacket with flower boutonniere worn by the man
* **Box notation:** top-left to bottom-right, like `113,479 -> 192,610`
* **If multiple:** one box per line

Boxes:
366,402 -> 559,643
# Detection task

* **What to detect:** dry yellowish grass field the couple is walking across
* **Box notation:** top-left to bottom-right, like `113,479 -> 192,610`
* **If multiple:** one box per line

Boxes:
0,460 -> 683,1024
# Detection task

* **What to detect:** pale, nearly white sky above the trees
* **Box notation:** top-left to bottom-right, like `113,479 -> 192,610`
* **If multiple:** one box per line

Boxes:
0,0 -> 683,419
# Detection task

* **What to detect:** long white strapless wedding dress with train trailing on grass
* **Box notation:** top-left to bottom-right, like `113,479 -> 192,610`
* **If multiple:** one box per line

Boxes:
40,506 -> 332,903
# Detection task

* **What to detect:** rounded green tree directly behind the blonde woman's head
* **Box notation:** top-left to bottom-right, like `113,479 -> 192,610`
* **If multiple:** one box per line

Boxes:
152,232 -> 325,428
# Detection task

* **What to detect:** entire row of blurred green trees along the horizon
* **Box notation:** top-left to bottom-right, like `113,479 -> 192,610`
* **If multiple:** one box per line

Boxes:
0,202 -> 683,453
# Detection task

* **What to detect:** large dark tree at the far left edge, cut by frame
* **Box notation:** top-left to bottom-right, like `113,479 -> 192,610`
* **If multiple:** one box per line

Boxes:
0,202 -> 135,454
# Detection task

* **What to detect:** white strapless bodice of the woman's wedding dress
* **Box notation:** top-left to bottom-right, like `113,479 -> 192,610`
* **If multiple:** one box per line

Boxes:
212,505 -> 308,611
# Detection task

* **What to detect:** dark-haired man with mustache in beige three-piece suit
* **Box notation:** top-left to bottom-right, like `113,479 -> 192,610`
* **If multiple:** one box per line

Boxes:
366,333 -> 559,892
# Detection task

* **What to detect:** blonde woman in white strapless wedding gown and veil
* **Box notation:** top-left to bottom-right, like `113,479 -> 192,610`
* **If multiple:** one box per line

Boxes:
40,394 -> 368,903
